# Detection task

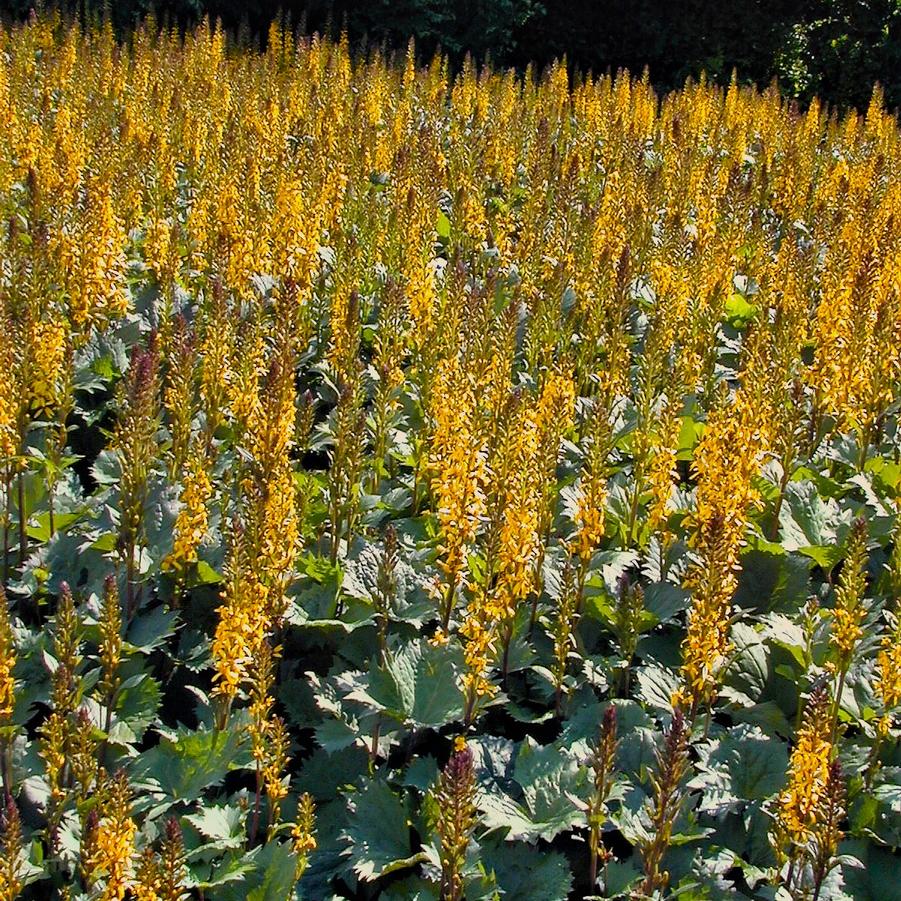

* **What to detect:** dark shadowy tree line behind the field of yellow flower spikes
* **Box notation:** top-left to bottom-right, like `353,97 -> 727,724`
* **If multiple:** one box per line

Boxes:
0,0 -> 901,108
